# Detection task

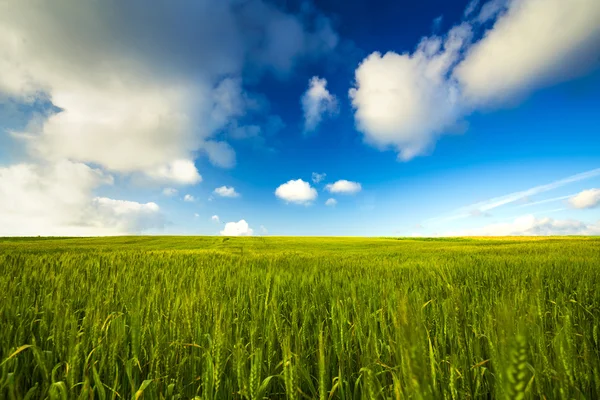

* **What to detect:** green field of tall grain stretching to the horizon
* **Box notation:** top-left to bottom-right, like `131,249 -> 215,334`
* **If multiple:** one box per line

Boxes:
0,237 -> 600,400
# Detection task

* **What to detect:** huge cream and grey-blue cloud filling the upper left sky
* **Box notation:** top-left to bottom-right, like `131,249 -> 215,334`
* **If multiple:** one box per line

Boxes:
0,0 -> 337,178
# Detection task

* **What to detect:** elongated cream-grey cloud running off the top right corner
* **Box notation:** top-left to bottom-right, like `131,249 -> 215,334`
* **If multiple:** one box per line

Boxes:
454,0 -> 600,104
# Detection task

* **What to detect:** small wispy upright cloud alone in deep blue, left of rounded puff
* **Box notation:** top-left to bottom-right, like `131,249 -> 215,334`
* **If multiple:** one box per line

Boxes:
301,76 -> 338,132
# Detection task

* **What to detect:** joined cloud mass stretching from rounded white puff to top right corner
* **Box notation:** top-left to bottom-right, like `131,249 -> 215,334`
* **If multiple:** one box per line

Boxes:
349,0 -> 600,160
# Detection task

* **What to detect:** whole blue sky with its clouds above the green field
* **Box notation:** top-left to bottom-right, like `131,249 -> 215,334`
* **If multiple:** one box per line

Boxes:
0,0 -> 600,236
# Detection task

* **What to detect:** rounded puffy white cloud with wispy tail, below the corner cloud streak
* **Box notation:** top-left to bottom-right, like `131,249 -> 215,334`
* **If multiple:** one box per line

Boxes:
350,24 -> 472,160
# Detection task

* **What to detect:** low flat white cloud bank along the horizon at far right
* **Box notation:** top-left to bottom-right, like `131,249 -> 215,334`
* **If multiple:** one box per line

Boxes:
444,214 -> 600,236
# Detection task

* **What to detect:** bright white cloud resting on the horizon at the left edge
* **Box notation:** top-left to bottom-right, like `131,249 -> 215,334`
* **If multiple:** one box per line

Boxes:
0,161 -> 165,236
